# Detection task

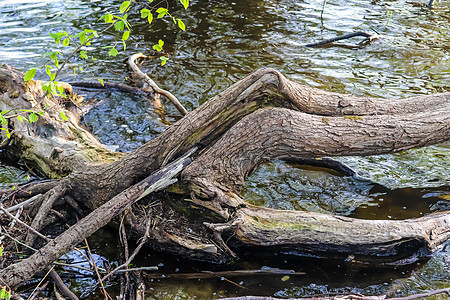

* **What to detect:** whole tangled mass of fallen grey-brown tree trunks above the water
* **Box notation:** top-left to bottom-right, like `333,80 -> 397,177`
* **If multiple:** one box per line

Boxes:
0,65 -> 450,288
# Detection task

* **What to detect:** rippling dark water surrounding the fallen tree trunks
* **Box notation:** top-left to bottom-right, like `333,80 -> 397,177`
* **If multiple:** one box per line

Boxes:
0,0 -> 450,299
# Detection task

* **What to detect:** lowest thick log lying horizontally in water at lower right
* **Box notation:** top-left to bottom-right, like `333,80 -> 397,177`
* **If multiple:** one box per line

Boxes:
229,206 -> 450,264
